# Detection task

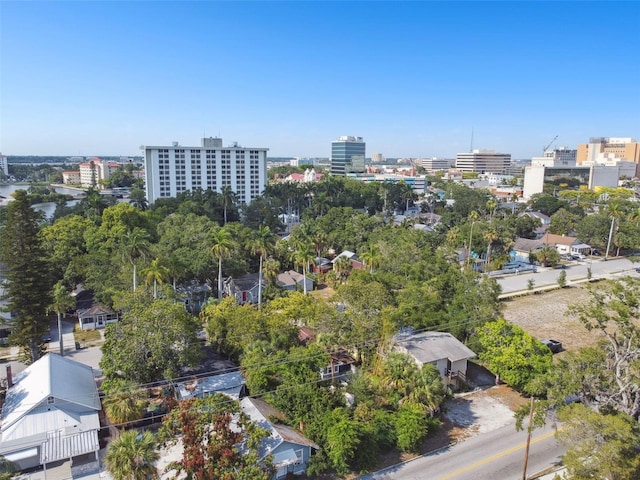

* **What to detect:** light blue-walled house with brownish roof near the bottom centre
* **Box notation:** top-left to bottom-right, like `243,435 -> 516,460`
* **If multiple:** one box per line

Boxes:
240,397 -> 320,479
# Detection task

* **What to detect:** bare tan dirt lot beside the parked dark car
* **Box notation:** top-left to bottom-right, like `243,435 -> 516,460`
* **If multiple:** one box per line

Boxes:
503,286 -> 602,350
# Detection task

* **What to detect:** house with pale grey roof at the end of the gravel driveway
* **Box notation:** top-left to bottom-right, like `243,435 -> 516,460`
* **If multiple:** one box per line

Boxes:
393,332 -> 476,383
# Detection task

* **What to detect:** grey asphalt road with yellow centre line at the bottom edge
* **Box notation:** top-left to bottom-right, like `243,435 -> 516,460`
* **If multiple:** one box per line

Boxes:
360,424 -> 565,480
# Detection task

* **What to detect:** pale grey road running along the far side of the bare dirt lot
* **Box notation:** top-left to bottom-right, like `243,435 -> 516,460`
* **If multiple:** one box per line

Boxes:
496,257 -> 640,294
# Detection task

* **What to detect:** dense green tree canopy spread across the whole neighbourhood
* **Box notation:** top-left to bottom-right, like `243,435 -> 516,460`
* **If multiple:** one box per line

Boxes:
0,172 -> 640,478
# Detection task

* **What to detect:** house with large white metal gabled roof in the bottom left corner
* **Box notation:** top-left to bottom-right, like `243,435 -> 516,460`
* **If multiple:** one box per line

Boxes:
0,353 -> 101,470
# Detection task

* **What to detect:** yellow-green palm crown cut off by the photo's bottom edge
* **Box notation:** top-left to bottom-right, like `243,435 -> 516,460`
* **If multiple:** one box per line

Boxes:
104,430 -> 160,480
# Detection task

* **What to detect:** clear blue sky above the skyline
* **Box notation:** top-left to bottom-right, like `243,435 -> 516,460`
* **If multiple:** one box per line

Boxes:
0,0 -> 640,158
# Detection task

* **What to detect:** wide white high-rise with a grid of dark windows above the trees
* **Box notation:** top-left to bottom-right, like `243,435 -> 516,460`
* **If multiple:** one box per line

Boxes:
143,137 -> 269,203
